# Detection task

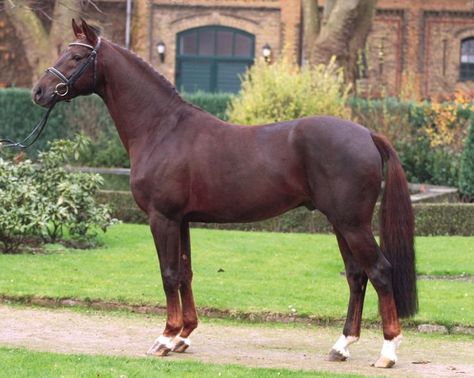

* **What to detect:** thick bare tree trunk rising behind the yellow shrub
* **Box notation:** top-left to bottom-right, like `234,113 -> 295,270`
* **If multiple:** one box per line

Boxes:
302,0 -> 377,87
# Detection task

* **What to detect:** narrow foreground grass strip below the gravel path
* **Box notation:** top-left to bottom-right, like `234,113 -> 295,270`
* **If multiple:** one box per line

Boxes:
0,348 -> 361,378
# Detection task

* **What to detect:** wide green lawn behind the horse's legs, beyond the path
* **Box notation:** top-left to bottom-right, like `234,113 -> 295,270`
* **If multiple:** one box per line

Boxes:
0,224 -> 474,325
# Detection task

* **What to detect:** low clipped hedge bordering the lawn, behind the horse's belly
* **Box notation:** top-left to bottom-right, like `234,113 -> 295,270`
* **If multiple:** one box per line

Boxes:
98,191 -> 474,236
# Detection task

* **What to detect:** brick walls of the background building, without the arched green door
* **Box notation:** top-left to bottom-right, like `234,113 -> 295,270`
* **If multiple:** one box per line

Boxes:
0,0 -> 474,97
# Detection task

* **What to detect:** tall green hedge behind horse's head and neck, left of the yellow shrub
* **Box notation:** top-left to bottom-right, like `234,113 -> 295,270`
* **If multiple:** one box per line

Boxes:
0,88 -> 232,167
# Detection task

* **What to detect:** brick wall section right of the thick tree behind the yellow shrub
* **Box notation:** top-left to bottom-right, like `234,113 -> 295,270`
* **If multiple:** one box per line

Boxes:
376,0 -> 474,97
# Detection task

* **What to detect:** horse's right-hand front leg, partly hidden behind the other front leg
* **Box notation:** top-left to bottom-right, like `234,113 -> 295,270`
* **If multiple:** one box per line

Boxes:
173,222 -> 198,353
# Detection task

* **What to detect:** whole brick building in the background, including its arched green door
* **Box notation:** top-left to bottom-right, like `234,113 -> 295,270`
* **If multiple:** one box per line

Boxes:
0,0 -> 474,97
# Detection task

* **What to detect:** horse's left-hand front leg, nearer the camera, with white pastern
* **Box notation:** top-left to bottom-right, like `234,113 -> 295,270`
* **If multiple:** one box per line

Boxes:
147,215 -> 183,356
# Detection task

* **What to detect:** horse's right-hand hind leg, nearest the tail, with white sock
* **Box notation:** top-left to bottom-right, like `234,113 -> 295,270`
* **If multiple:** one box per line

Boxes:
339,225 -> 402,368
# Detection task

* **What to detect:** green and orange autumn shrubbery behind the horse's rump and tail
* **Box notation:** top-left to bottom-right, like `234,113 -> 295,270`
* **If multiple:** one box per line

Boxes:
349,95 -> 466,187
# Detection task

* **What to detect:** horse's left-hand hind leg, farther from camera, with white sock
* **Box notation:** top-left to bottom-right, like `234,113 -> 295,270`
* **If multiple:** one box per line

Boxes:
329,228 -> 367,361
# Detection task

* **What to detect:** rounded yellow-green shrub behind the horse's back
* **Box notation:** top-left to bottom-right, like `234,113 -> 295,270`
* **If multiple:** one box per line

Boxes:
228,60 -> 350,125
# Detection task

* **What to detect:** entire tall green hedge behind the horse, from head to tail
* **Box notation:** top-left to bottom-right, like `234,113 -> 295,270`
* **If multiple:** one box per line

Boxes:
0,88 -> 473,187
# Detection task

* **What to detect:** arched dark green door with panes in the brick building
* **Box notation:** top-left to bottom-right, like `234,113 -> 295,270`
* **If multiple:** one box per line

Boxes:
176,26 -> 255,93
